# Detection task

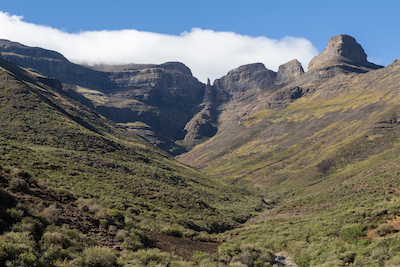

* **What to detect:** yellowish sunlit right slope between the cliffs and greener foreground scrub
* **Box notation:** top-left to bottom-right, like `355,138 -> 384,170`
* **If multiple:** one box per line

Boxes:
181,59 -> 400,201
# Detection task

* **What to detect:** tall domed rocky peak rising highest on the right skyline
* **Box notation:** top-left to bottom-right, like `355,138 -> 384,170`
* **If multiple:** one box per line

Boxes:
308,34 -> 380,71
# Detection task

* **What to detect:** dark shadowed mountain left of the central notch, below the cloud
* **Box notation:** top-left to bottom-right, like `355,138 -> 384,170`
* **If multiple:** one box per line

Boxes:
0,40 -> 205,154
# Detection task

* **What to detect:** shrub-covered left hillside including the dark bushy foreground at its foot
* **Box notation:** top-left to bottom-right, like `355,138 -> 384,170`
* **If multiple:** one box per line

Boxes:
0,51 -> 278,267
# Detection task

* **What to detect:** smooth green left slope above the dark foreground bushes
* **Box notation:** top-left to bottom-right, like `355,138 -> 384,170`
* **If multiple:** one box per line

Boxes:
0,61 -> 260,237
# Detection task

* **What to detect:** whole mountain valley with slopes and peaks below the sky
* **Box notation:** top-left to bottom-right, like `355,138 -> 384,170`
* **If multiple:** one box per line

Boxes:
0,35 -> 400,266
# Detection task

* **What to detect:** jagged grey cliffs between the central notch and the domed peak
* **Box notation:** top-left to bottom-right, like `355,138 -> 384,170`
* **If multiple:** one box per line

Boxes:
184,60 -> 304,145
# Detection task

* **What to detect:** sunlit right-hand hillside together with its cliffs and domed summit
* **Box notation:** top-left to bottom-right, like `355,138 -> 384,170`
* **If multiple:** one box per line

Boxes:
180,36 -> 390,196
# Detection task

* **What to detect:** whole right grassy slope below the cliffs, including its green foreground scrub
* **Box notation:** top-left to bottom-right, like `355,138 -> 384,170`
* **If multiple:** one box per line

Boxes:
181,62 -> 400,266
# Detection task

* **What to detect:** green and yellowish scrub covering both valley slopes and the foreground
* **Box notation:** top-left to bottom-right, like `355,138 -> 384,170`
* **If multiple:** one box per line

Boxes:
0,46 -> 400,267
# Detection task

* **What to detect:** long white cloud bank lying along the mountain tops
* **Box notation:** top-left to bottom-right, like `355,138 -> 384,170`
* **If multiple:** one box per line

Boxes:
0,11 -> 318,82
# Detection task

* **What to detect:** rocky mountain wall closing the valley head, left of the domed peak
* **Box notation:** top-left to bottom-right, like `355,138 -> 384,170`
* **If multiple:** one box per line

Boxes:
0,40 -> 310,155
